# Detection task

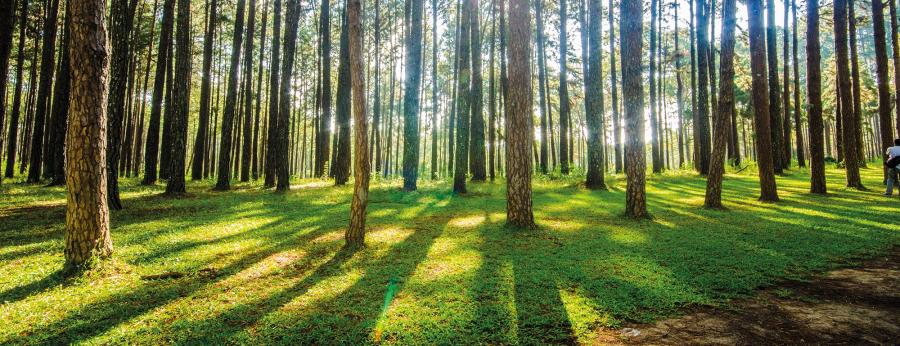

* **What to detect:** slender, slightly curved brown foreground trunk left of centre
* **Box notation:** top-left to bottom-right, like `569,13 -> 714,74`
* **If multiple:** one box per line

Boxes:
345,0 -> 369,248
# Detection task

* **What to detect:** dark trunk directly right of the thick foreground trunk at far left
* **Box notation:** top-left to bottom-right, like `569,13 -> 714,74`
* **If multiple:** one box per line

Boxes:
106,0 -> 134,210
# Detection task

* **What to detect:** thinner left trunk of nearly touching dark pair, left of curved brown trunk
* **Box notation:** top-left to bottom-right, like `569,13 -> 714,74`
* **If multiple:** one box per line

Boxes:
263,0 -> 281,188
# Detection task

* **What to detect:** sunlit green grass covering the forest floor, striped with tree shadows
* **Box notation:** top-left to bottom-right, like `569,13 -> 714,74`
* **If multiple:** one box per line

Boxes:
0,169 -> 900,344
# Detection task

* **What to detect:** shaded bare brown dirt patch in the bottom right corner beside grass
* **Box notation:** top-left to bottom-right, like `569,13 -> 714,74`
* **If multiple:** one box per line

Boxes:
596,248 -> 900,345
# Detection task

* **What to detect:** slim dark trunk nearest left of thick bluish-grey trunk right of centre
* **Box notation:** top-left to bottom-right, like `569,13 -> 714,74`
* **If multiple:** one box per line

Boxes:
551,0 -> 571,175
